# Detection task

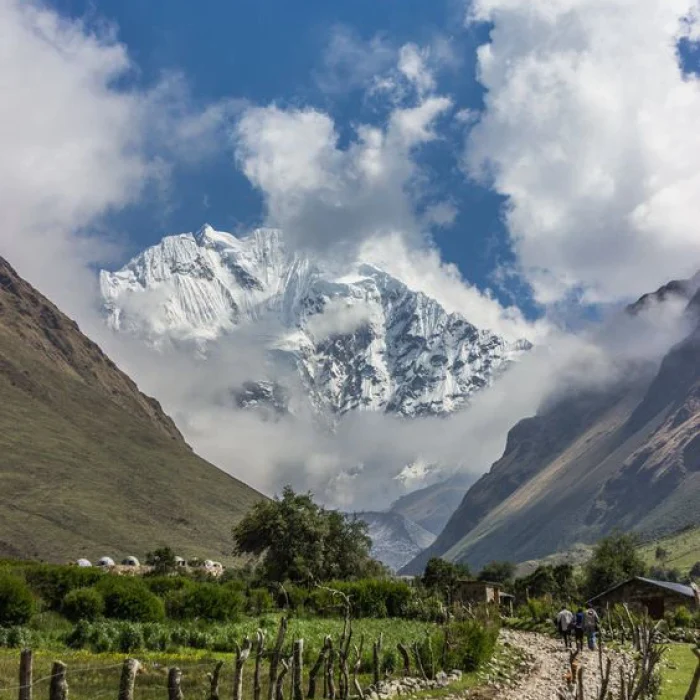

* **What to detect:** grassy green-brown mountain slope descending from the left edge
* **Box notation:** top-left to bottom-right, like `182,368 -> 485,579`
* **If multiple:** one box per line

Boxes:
0,258 -> 262,561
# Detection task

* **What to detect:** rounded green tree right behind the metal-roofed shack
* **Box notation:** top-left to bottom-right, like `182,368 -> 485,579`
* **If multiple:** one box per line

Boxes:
585,533 -> 646,597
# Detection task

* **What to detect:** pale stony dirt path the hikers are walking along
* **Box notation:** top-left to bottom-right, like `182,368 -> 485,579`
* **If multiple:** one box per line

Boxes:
482,630 -> 630,700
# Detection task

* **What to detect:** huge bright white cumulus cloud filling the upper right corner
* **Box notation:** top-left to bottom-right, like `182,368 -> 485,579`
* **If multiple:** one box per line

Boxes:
465,0 -> 700,303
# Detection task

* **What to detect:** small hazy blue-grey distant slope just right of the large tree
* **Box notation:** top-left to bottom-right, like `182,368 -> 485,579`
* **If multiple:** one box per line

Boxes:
356,511 -> 435,571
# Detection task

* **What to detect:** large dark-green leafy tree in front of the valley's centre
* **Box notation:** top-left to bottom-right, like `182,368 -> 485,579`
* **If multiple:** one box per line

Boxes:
233,486 -> 382,582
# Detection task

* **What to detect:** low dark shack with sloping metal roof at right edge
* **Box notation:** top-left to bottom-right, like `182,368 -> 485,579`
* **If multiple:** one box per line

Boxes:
588,576 -> 700,620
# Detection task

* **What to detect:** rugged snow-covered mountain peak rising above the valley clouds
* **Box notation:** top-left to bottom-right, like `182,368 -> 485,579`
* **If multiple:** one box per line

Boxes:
100,225 -> 530,416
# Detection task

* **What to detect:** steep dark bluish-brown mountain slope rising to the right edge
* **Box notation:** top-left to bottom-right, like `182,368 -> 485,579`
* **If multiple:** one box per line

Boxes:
406,280 -> 700,573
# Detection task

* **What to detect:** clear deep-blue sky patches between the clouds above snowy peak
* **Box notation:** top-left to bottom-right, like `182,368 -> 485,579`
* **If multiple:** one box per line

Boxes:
54,0 -> 520,314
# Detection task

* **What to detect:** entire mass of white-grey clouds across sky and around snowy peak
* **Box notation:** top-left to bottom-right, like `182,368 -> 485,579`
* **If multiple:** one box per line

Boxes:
0,0 -> 700,508
